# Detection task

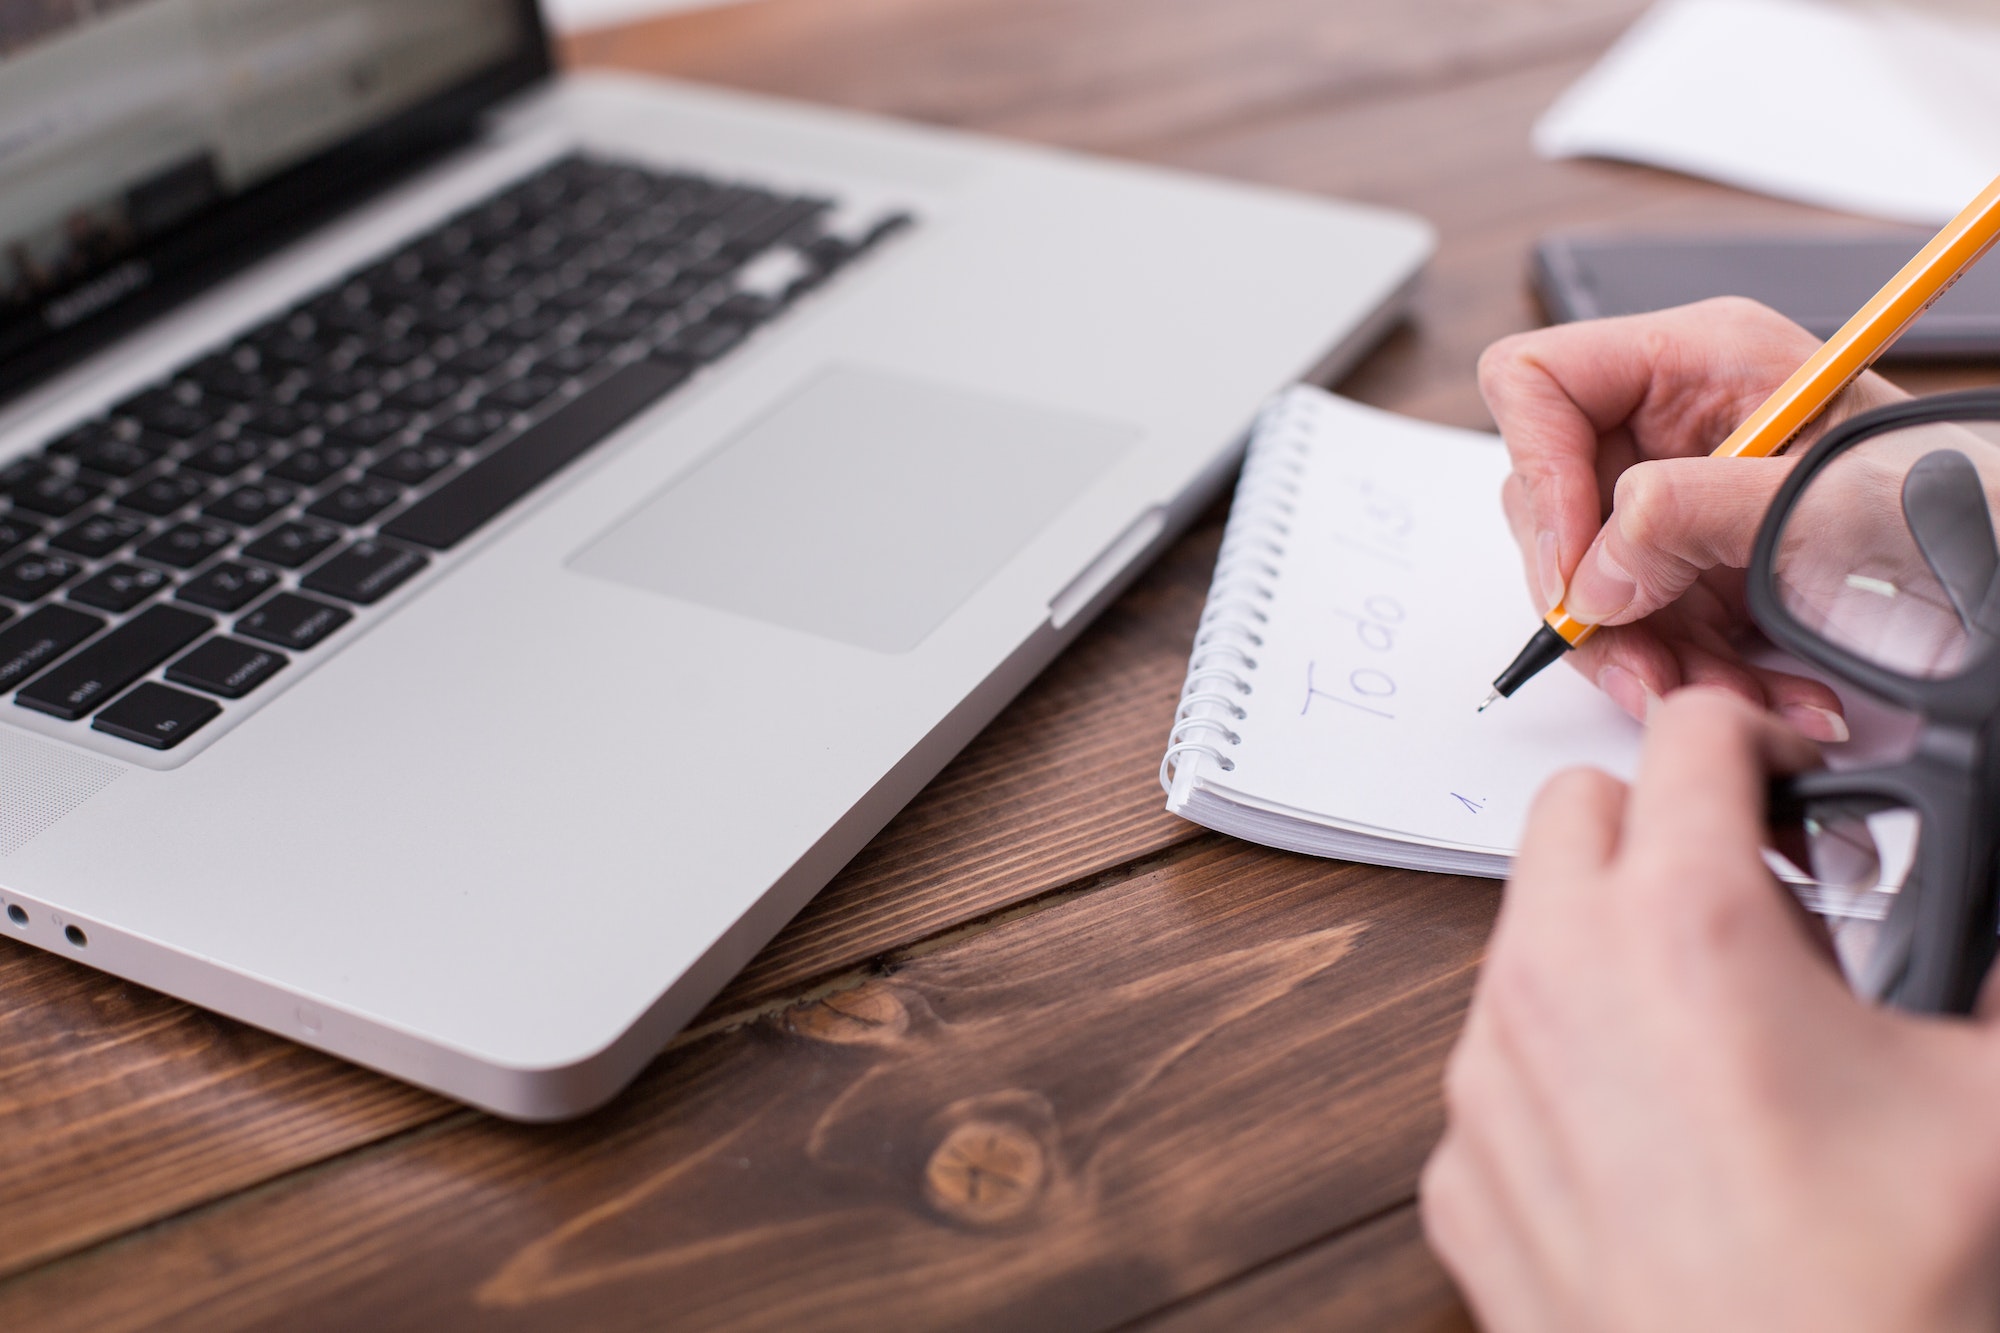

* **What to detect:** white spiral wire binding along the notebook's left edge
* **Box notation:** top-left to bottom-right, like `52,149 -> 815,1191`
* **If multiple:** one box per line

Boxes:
1160,394 -> 1312,793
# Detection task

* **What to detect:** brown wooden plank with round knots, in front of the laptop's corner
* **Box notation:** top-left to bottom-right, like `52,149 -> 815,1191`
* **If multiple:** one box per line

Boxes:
0,839 -> 1496,1329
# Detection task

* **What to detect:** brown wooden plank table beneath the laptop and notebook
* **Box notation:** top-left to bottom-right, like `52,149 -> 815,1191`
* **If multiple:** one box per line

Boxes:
0,0 -> 1994,1329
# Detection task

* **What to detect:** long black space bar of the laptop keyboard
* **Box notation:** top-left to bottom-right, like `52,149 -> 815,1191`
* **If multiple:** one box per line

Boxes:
382,360 -> 688,550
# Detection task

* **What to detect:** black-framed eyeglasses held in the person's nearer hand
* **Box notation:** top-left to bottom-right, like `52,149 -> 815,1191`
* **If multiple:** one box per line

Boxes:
1748,390 -> 2000,1013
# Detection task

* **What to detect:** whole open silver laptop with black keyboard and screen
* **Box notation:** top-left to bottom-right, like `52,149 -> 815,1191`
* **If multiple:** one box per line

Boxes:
0,0 -> 1432,1119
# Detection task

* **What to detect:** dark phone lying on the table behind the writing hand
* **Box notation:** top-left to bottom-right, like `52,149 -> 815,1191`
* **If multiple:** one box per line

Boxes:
1534,230 -> 2000,360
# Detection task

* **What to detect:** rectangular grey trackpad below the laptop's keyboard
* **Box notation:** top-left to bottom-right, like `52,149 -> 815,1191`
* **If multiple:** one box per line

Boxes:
570,370 -> 1140,652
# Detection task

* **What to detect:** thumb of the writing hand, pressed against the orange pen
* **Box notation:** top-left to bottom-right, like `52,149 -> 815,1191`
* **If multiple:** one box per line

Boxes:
1564,458 -> 1794,624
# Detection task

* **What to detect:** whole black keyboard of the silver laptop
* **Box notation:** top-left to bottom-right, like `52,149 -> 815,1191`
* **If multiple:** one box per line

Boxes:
0,156 -> 910,751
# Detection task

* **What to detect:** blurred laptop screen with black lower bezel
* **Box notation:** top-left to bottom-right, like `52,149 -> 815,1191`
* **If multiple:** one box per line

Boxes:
0,0 -> 548,392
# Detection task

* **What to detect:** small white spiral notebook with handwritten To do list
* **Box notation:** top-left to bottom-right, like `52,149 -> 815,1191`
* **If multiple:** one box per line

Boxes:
1160,386 -> 1640,877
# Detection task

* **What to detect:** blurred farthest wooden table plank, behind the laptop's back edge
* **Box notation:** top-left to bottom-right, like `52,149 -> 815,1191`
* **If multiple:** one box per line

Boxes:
570,0 -> 1644,156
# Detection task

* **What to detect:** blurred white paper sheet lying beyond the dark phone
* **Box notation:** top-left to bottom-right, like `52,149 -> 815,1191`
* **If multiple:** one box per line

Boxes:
1534,0 -> 2000,224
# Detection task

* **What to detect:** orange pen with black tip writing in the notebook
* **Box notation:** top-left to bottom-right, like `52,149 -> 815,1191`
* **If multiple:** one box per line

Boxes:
1480,178 -> 2000,713
